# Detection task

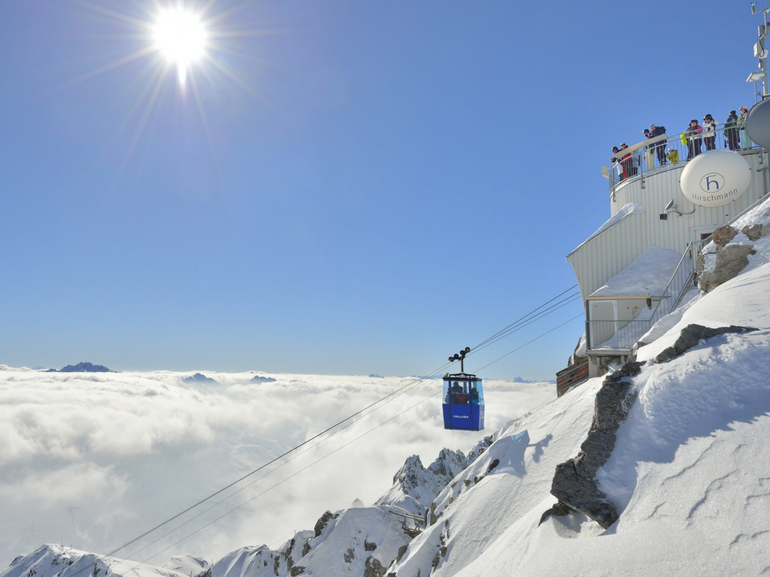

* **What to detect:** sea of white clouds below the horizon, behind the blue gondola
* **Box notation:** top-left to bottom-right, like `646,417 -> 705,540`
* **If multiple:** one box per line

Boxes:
0,366 -> 555,567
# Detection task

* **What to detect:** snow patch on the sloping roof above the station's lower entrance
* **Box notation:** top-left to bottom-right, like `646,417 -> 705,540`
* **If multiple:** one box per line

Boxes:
589,245 -> 682,297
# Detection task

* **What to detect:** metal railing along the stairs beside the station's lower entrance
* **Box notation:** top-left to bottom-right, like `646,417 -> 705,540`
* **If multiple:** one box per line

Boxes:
586,243 -> 701,351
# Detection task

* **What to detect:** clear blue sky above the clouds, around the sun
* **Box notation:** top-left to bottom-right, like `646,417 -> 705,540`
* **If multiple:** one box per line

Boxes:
0,0 -> 764,379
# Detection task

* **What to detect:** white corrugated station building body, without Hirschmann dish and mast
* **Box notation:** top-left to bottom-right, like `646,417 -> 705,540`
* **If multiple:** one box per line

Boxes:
567,127 -> 770,376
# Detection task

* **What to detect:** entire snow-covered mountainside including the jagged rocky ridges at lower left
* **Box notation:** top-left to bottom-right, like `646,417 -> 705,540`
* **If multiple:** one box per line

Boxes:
6,201 -> 770,577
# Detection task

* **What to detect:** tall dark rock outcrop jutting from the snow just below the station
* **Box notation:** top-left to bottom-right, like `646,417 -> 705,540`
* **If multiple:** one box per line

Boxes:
541,361 -> 643,529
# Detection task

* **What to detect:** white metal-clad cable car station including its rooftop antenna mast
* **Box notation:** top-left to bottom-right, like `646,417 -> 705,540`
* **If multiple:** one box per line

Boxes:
556,10 -> 770,395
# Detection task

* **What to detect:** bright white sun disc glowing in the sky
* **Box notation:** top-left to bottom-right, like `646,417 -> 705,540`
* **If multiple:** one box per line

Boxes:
153,7 -> 206,84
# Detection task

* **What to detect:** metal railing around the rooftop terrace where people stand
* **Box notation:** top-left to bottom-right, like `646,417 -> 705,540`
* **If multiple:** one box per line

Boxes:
606,124 -> 759,193
